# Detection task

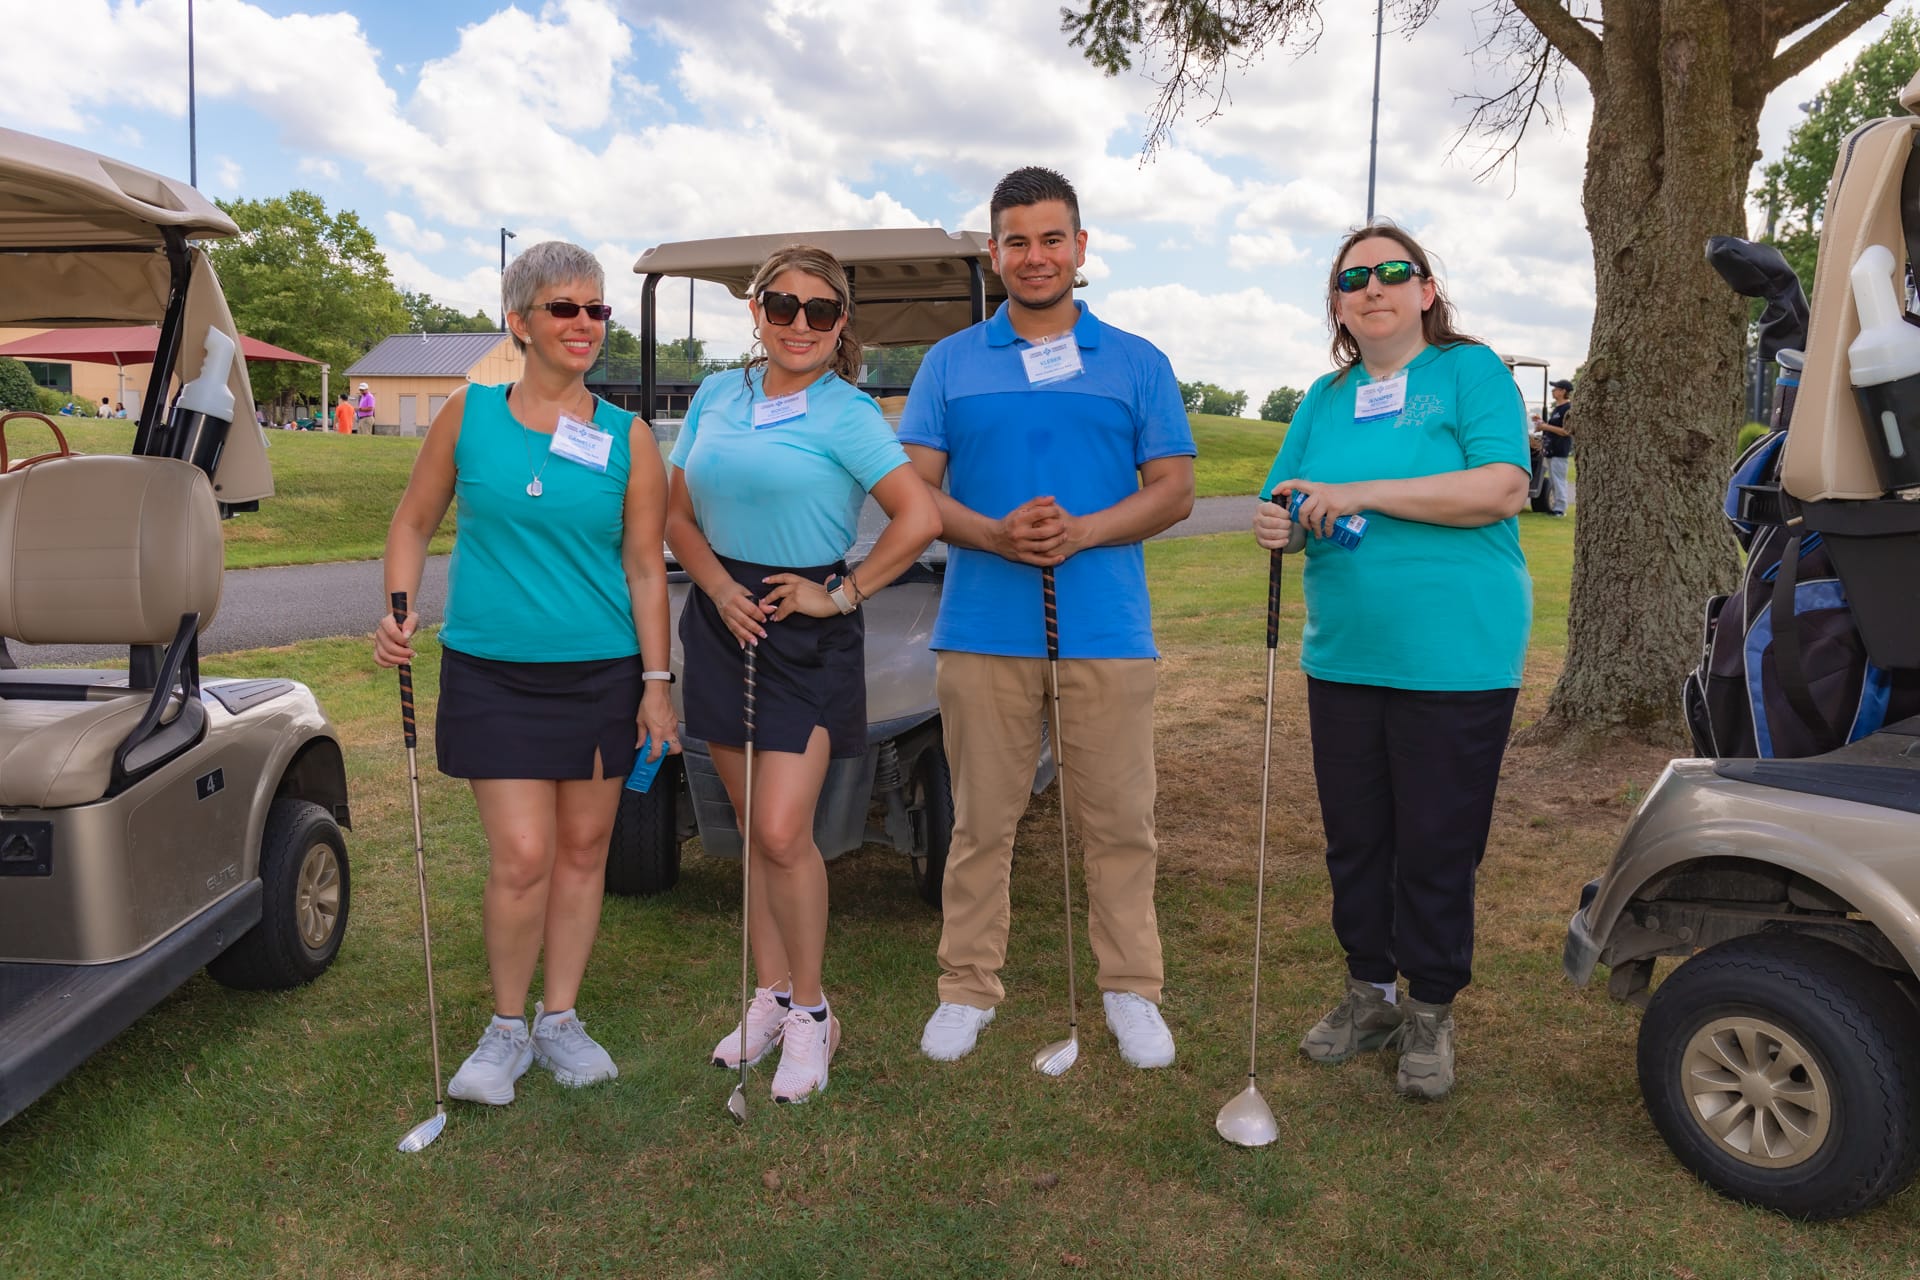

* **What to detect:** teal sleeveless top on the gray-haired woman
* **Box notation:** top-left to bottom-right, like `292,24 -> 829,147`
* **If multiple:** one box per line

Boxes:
440,386 -> 639,662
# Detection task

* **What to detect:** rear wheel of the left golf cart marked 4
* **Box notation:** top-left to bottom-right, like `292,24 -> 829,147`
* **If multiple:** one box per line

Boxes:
207,798 -> 351,990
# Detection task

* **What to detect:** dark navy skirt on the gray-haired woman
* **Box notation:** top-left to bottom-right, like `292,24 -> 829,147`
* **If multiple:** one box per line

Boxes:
434,649 -> 641,781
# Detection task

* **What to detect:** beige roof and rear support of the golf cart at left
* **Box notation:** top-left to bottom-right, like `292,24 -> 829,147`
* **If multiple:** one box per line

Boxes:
0,129 -> 273,505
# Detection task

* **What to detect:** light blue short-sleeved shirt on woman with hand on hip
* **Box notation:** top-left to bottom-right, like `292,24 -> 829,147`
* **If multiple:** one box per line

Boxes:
668,368 -> 906,568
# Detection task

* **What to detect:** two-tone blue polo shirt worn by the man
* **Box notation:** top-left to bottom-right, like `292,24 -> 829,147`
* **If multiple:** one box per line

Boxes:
900,303 -> 1194,658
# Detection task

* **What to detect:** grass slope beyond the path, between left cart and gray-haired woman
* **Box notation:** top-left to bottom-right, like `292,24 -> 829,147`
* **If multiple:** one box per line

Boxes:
8,418 -> 453,568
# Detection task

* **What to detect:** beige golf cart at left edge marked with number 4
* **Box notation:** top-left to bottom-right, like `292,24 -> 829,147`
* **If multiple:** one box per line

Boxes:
0,129 -> 349,1123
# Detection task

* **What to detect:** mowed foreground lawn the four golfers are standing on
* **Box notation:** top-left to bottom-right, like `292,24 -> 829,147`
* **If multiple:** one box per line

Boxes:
0,514 -> 1920,1280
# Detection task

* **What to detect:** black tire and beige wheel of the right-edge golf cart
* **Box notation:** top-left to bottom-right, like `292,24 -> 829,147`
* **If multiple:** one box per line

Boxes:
1640,933 -> 1920,1219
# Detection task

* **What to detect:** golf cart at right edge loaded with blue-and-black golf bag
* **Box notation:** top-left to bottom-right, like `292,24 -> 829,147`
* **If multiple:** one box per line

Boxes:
1563,77 -> 1920,1219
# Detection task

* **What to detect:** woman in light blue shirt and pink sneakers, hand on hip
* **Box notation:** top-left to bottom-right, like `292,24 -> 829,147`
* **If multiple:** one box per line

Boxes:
666,246 -> 941,1102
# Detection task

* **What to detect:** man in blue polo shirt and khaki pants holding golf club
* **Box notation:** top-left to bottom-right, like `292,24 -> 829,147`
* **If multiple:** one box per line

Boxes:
900,167 -> 1194,1067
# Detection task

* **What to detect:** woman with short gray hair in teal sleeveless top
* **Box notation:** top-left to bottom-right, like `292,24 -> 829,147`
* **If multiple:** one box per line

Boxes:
374,240 -> 680,1105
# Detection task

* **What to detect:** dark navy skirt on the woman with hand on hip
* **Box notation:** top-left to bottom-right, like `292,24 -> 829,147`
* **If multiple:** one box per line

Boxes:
680,557 -> 866,758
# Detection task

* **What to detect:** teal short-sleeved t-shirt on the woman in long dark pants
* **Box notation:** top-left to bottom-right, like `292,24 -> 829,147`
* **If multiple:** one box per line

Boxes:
1260,344 -> 1534,689
